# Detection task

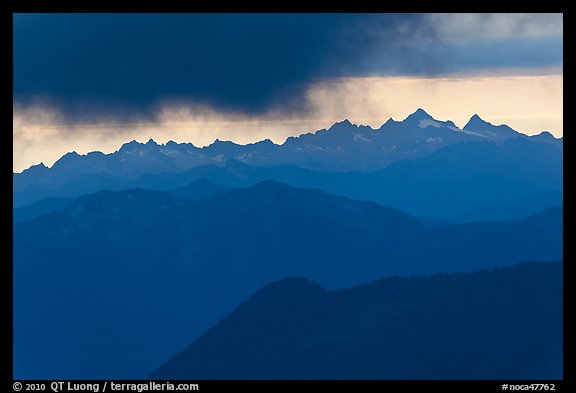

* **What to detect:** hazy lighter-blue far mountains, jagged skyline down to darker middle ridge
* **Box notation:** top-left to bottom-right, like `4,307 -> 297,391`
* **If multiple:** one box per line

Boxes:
14,109 -> 563,219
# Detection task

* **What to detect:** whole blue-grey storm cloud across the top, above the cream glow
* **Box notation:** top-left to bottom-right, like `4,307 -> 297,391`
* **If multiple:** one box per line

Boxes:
14,14 -> 562,118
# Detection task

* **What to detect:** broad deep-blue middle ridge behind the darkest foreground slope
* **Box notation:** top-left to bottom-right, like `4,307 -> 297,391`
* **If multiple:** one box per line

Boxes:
14,181 -> 563,379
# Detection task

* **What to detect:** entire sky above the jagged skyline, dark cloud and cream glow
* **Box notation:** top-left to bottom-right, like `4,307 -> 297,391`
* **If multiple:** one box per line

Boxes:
13,14 -> 563,172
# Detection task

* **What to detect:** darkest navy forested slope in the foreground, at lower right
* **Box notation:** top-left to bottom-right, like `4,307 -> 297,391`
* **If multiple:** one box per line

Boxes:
151,262 -> 563,380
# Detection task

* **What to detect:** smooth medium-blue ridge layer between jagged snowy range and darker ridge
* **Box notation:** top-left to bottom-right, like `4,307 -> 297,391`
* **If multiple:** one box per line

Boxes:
14,138 -> 563,217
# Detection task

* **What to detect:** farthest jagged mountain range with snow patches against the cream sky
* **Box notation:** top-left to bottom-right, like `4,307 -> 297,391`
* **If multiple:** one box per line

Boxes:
12,108 -> 562,195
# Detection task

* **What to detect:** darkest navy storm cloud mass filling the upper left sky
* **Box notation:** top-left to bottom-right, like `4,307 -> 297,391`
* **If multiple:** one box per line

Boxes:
14,14 -> 374,117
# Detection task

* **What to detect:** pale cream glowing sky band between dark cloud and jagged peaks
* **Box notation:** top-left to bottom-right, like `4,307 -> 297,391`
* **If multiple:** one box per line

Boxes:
13,74 -> 563,171
